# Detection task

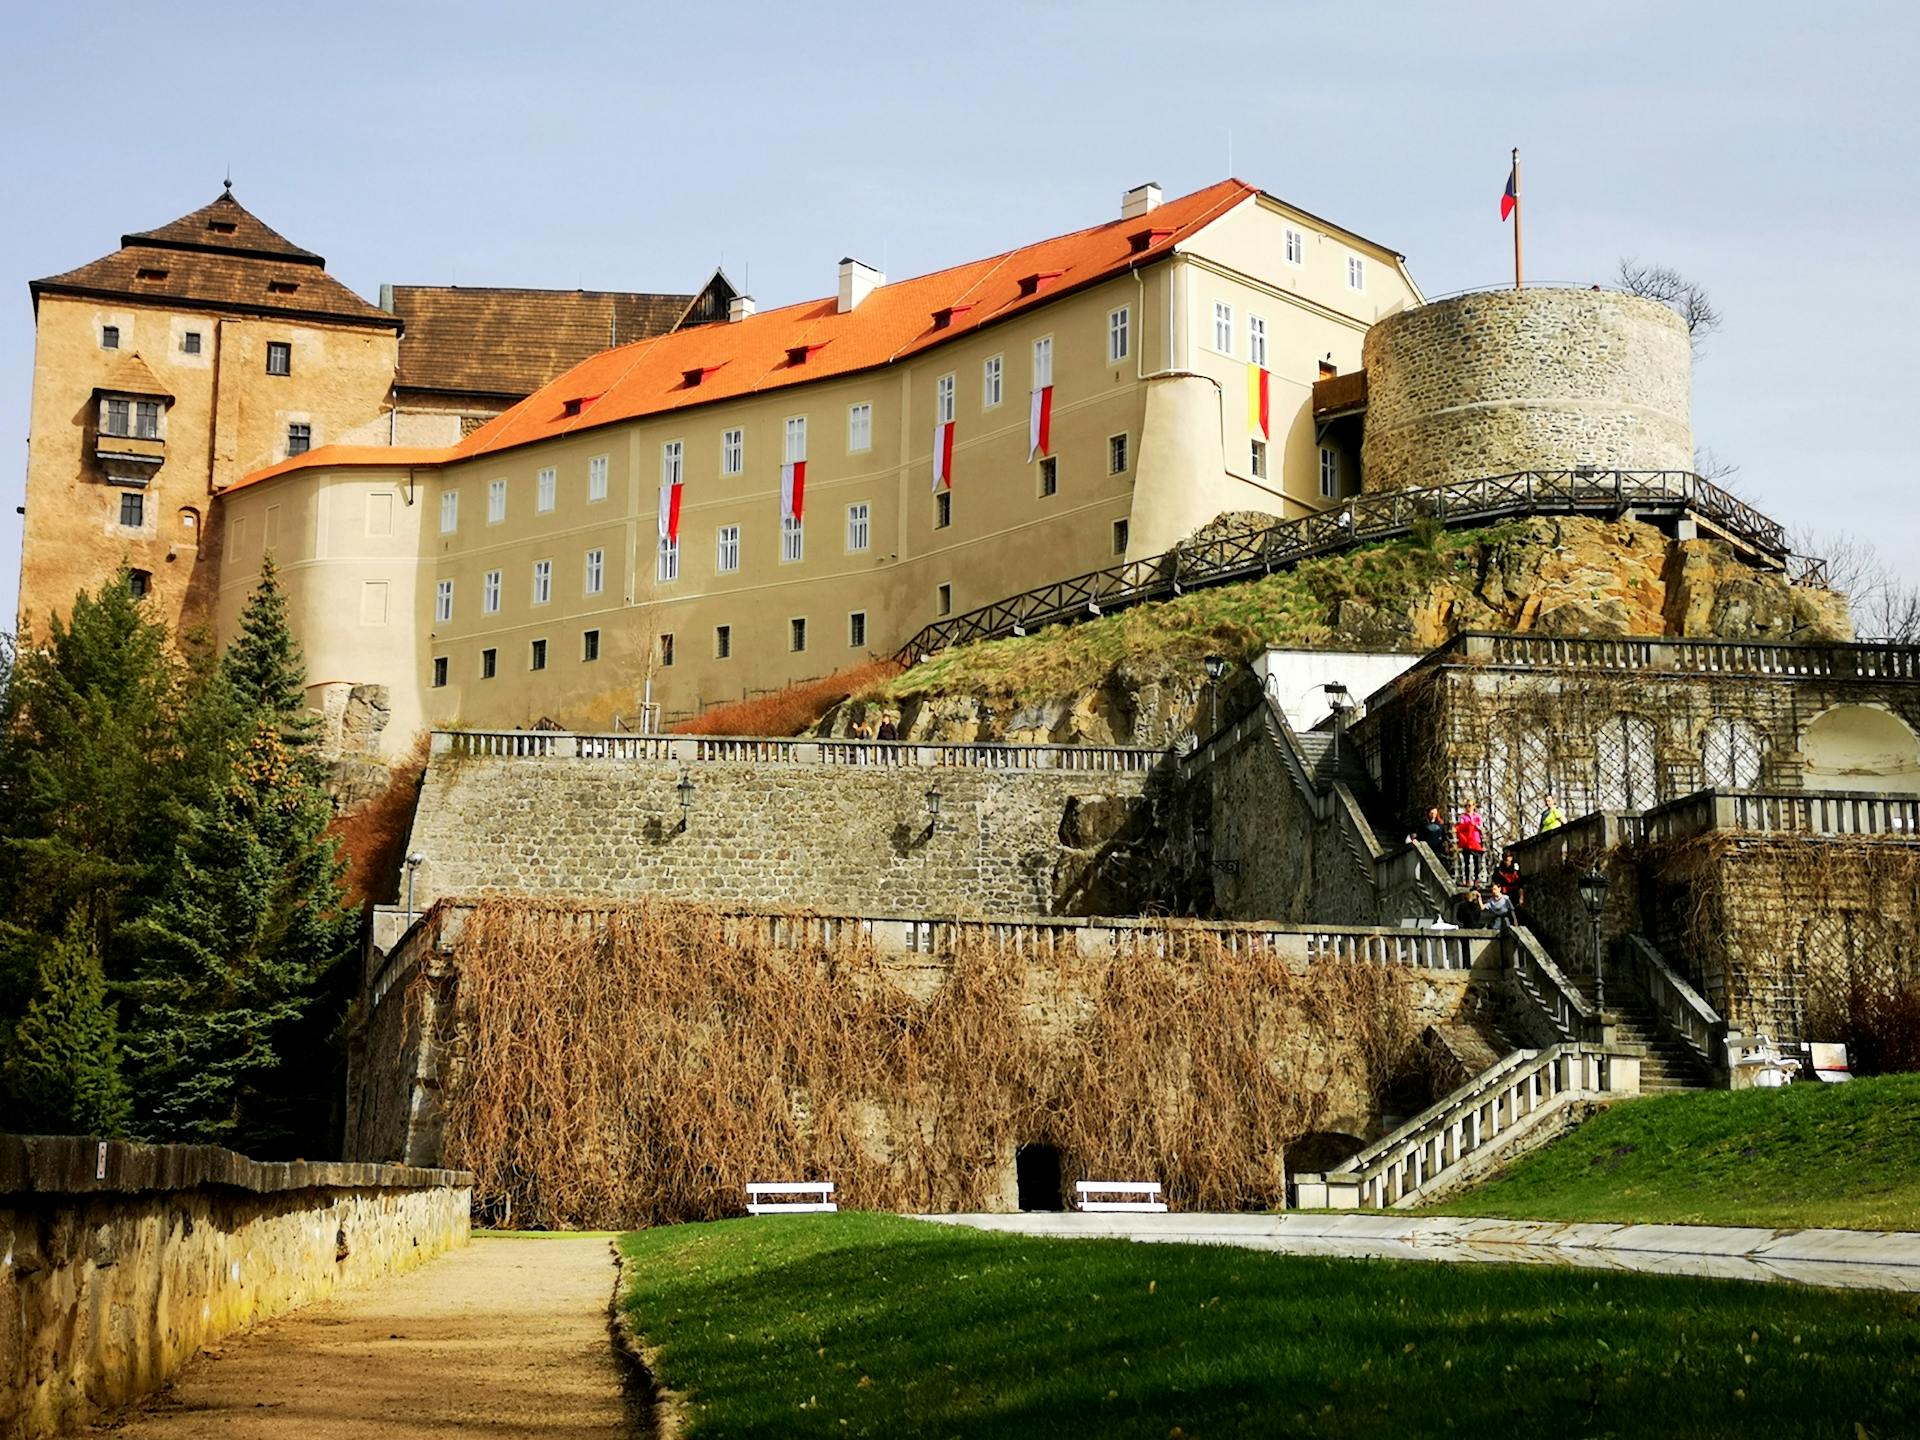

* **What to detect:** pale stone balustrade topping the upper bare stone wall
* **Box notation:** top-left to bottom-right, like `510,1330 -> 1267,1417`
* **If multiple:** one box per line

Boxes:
432,730 -> 1165,774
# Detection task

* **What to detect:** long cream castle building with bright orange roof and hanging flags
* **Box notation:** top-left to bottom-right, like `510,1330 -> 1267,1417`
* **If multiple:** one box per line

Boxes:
202,180 -> 1421,749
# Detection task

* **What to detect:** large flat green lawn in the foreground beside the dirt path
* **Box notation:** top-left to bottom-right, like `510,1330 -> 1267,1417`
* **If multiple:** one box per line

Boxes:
620,1213 -> 1920,1440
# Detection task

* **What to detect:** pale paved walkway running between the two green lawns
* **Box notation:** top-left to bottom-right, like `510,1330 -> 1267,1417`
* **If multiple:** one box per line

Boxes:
920,1212 -> 1920,1292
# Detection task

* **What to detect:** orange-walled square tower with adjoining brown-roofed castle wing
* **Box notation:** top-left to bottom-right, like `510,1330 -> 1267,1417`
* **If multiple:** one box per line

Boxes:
19,188 -> 733,637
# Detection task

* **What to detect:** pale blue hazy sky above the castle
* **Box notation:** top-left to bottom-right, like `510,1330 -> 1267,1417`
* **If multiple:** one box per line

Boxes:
0,0 -> 1920,620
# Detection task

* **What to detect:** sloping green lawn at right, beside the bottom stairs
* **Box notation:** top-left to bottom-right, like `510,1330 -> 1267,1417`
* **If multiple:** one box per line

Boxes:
1430,1075 -> 1920,1231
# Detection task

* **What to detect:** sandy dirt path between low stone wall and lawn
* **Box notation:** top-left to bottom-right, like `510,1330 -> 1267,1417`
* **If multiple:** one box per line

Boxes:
100,1238 -> 628,1440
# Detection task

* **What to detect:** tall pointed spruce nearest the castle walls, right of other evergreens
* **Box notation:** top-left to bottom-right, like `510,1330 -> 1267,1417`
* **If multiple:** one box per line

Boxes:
127,566 -> 357,1152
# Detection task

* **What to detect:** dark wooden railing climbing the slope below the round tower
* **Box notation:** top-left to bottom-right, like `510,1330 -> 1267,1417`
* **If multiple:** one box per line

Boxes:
897,470 -> 1788,664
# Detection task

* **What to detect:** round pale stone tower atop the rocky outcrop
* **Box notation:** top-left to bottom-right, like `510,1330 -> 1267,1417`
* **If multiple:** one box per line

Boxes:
1361,290 -> 1693,492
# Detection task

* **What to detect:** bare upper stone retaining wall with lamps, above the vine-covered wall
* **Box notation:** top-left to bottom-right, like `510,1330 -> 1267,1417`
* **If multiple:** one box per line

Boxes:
409,755 -> 1152,916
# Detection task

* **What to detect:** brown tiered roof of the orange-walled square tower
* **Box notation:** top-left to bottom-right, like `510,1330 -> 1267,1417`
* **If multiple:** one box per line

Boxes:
27,190 -> 401,330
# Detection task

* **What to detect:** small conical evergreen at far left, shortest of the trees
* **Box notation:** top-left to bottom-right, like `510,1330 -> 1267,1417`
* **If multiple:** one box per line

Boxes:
0,912 -> 131,1135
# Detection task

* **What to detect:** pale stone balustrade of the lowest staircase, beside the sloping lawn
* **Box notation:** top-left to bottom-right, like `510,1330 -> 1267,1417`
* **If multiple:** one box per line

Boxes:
1292,1044 -> 1640,1210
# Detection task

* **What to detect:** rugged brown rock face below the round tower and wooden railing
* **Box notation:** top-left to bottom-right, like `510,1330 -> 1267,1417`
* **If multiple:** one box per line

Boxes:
818,515 -> 1853,745
